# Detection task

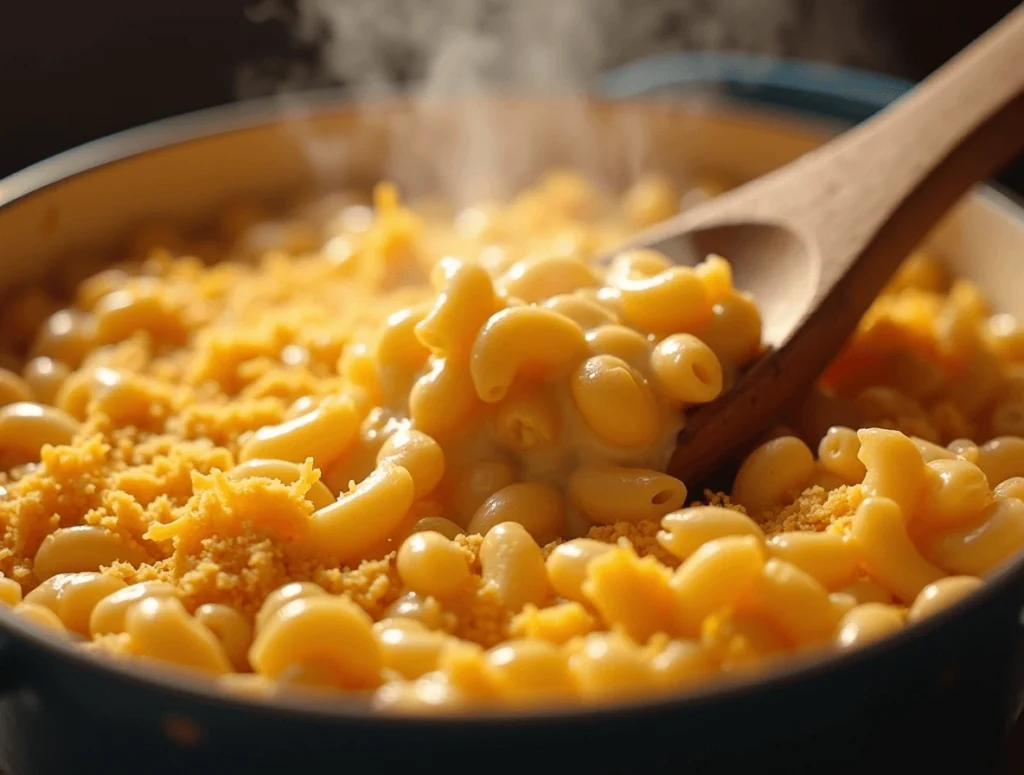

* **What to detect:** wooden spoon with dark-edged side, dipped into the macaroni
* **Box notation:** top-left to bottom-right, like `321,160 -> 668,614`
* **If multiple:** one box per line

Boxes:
614,5 -> 1024,482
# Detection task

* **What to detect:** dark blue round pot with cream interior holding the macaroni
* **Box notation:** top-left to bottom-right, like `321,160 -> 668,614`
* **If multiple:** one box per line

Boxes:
0,57 -> 1024,772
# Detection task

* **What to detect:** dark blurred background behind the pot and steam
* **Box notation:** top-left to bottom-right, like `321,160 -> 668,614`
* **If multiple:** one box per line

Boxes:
0,0 -> 1017,183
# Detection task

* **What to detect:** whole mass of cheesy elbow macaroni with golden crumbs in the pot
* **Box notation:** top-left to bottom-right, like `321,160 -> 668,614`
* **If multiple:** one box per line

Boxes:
0,172 -> 1024,713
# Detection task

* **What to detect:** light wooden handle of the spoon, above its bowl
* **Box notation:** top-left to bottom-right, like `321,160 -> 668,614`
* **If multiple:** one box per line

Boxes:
775,4 -> 1024,290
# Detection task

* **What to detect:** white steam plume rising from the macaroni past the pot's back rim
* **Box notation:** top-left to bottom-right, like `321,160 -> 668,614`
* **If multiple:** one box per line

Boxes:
276,0 -> 675,203
